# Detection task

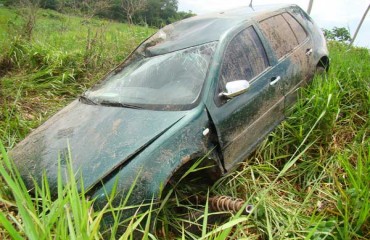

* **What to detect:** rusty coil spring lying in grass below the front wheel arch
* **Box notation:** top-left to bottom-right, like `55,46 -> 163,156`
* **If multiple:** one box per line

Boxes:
209,196 -> 253,214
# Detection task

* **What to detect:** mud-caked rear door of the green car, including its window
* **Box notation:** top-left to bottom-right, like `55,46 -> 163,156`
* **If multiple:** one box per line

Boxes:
259,12 -> 313,107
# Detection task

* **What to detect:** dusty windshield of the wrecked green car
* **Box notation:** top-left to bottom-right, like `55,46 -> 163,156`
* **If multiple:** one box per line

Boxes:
85,42 -> 216,109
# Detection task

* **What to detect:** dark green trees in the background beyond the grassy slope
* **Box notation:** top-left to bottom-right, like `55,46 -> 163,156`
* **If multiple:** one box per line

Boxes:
4,0 -> 195,27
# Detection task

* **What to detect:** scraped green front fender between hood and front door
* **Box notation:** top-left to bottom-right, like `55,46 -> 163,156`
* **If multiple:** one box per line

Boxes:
93,105 -> 215,213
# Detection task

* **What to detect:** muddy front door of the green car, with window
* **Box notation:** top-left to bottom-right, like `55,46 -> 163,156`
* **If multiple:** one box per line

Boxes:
207,26 -> 284,170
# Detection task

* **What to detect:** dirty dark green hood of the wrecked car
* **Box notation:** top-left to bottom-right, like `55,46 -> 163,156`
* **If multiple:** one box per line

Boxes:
10,100 -> 187,193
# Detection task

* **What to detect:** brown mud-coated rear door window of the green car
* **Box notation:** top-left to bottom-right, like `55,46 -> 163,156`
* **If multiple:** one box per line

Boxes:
260,15 -> 298,59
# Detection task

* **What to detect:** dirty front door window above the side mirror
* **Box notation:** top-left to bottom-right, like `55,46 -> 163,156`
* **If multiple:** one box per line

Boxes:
220,27 -> 269,85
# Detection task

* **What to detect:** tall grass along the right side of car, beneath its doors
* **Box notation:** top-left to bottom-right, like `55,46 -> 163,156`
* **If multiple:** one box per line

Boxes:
155,42 -> 370,239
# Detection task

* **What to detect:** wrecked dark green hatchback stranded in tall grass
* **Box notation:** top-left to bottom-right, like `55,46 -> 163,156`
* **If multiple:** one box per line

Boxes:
10,5 -> 329,224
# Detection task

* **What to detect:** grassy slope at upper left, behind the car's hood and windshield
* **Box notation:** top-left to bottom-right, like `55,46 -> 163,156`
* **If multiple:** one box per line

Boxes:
0,8 -> 155,147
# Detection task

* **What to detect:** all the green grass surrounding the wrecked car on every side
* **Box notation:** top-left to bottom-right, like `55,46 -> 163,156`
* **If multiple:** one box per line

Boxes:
0,8 -> 370,239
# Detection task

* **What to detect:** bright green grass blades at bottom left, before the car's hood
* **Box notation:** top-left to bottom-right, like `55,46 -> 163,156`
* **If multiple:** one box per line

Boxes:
0,144 -> 155,239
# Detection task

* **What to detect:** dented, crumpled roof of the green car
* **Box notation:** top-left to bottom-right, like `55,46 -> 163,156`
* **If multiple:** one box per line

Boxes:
144,4 -> 297,56
